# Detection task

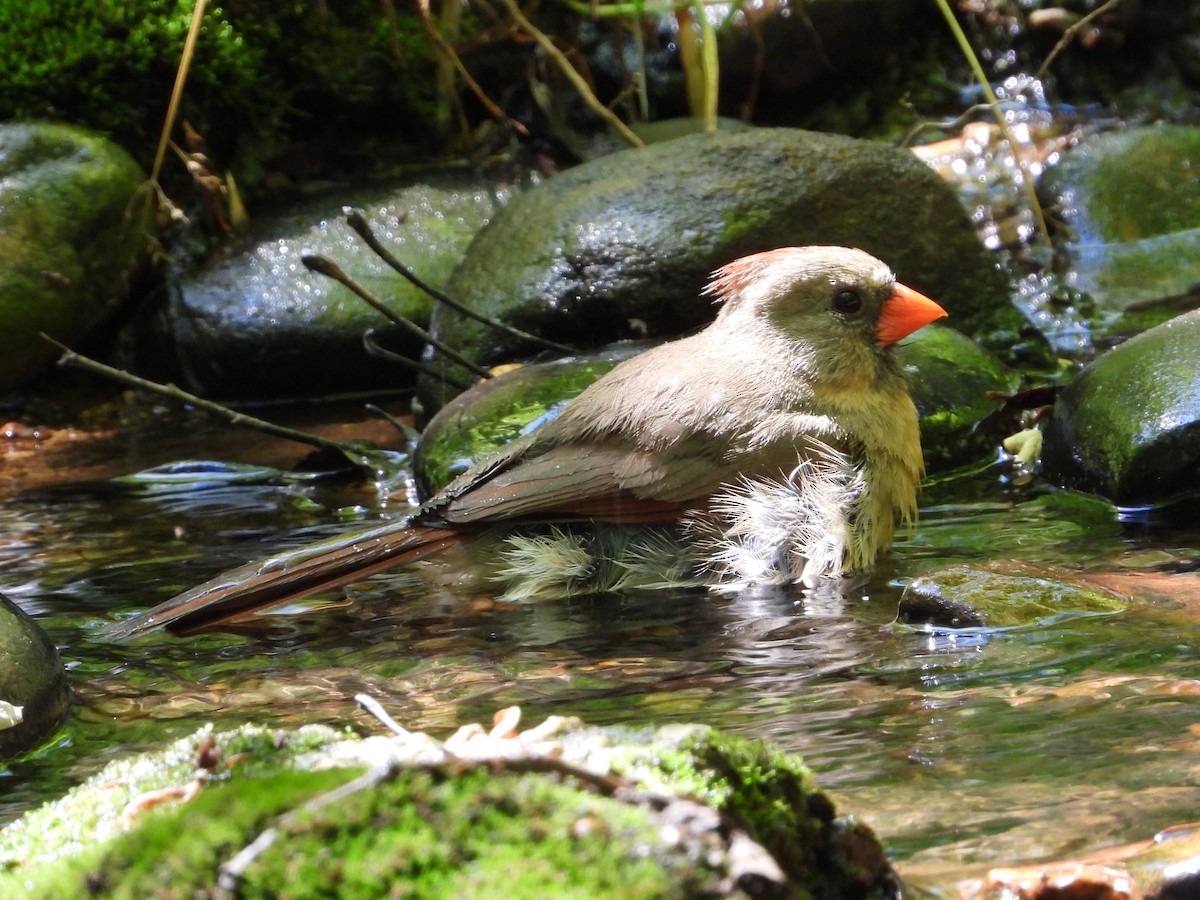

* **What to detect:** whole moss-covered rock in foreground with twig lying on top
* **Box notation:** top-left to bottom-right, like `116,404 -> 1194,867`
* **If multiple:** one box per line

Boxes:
0,720 -> 898,900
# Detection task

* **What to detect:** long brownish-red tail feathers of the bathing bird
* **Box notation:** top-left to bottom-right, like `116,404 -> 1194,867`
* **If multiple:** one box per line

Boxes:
103,522 -> 466,641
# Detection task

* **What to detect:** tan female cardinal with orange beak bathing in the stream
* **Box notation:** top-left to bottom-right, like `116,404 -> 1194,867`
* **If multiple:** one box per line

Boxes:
106,246 -> 947,640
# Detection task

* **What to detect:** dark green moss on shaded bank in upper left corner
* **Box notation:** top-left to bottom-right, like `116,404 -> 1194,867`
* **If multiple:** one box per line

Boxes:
0,0 -> 430,184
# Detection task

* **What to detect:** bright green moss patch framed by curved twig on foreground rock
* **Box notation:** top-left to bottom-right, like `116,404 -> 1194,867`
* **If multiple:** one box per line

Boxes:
242,769 -> 686,899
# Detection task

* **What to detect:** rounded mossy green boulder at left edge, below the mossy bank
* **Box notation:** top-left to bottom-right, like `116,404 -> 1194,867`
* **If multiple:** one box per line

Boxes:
0,122 -> 154,390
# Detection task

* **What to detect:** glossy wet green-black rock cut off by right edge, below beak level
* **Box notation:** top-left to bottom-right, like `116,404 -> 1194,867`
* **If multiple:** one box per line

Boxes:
1042,310 -> 1200,504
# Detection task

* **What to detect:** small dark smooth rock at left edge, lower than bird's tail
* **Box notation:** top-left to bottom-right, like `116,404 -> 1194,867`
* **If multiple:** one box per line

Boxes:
0,594 -> 71,757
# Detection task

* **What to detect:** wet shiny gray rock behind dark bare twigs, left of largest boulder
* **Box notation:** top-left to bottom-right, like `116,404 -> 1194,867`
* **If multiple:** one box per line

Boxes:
163,170 -> 494,397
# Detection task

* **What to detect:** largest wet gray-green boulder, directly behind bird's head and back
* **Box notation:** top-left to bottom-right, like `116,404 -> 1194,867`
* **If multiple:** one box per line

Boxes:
421,128 -> 1020,412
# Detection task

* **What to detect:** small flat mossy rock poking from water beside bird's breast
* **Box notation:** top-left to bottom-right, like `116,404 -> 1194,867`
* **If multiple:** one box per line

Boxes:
899,560 -> 1124,629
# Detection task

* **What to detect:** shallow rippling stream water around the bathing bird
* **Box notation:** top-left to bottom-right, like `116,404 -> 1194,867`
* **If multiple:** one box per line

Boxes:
0,408 -> 1200,884
